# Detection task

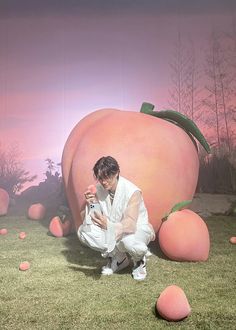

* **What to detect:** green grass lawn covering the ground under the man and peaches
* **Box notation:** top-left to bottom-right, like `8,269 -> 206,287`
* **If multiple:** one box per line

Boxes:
0,216 -> 236,330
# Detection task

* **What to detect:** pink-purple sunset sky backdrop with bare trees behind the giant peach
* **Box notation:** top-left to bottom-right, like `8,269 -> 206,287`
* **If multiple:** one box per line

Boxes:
0,0 -> 236,195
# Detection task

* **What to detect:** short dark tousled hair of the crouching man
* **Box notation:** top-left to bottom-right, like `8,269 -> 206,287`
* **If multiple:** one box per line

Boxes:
93,156 -> 120,179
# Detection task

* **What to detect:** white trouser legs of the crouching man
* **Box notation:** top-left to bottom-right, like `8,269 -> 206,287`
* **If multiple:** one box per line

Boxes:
78,224 -> 155,261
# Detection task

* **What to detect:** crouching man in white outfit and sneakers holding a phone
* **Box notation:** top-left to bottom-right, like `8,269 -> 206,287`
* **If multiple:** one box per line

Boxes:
78,156 -> 155,280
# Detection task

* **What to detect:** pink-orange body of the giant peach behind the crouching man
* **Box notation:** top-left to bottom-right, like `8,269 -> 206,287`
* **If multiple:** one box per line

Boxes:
62,109 -> 199,232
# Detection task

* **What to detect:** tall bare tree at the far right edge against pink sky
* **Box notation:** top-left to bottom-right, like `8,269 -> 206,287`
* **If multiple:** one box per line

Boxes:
205,32 -> 235,153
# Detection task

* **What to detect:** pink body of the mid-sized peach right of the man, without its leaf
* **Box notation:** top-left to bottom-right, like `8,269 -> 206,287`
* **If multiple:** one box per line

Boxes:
158,210 -> 210,261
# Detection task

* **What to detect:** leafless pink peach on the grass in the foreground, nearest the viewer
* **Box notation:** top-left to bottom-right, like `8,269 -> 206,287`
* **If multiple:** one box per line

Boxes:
156,285 -> 191,321
